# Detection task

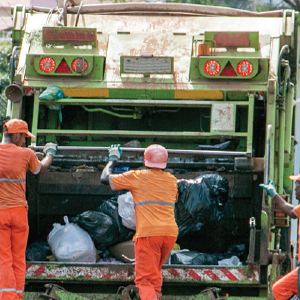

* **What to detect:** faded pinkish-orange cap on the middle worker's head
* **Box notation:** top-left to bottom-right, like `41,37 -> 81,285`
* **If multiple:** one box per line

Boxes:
144,144 -> 168,169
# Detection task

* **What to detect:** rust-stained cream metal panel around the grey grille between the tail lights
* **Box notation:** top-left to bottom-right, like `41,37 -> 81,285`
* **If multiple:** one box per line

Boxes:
105,33 -> 192,87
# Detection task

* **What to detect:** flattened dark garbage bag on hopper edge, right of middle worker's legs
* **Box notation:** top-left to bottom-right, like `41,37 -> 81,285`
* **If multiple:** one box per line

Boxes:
171,251 -> 218,265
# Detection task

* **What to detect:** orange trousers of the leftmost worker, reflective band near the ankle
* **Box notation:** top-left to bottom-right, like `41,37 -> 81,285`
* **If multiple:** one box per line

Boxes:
0,207 -> 29,300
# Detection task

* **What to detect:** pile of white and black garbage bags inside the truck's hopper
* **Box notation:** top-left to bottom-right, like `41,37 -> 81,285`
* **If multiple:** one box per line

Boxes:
27,174 -> 241,265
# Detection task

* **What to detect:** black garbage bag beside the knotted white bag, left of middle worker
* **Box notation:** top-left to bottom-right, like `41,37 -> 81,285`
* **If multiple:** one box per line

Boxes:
70,210 -> 119,250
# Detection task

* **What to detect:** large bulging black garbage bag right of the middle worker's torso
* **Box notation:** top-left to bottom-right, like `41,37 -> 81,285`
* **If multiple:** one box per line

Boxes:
175,174 -> 228,238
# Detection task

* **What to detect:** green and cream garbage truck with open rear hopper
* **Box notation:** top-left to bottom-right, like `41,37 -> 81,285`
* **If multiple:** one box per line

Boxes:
5,1 -> 299,300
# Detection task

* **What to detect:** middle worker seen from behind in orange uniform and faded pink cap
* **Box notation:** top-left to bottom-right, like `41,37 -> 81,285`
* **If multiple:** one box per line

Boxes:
101,145 -> 178,300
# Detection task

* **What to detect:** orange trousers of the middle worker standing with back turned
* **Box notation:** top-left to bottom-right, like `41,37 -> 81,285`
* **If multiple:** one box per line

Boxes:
134,236 -> 176,300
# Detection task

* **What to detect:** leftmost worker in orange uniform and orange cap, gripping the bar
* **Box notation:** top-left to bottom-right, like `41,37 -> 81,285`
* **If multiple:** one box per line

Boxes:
0,119 -> 57,300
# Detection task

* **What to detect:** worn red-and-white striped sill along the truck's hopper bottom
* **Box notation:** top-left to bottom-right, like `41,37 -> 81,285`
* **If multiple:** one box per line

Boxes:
26,262 -> 260,285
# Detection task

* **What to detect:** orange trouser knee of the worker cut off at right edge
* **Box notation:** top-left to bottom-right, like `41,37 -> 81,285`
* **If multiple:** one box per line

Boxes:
272,267 -> 299,300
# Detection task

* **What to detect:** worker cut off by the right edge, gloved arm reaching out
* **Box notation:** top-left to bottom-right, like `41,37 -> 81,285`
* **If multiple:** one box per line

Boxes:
259,174 -> 300,300
